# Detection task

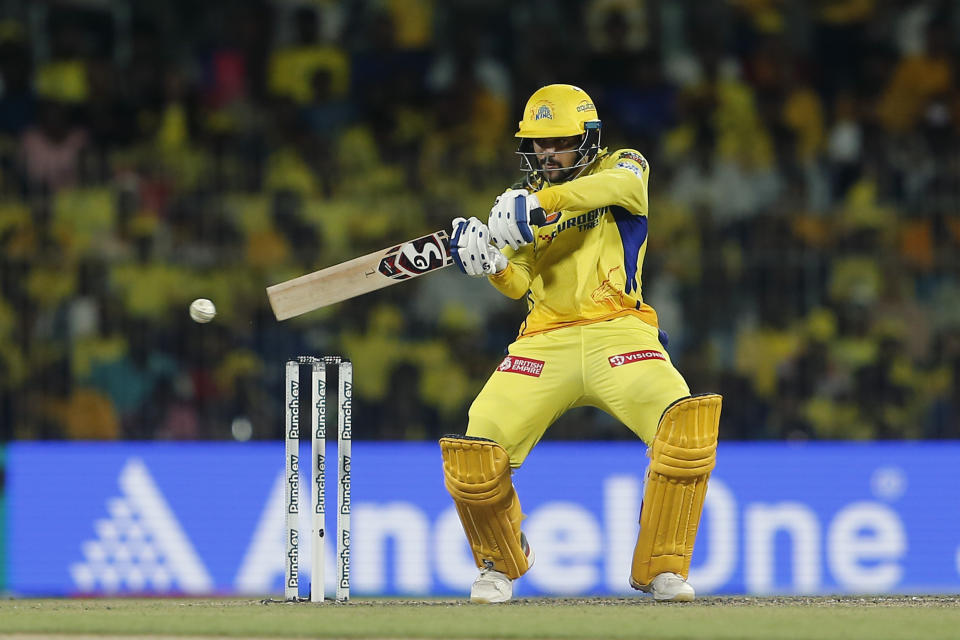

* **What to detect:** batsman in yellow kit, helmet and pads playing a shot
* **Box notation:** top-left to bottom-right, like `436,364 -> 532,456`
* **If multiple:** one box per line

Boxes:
440,84 -> 720,603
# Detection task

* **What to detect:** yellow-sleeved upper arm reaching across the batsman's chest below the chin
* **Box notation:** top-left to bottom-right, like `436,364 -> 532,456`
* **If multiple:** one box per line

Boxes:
537,169 -> 647,214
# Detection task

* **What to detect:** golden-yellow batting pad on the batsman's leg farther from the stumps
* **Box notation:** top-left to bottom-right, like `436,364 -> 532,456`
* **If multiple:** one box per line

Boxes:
630,394 -> 721,589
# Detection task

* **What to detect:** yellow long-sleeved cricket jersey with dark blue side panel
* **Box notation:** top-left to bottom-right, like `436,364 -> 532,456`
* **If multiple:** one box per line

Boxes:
490,149 -> 658,337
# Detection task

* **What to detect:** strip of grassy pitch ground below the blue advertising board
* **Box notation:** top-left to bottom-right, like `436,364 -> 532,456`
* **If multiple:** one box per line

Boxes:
0,595 -> 960,640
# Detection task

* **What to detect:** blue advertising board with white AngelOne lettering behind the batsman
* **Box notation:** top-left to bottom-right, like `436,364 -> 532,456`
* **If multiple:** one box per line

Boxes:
6,442 -> 960,595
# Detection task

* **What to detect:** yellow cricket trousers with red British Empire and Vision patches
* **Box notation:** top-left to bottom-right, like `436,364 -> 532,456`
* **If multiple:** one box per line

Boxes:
466,316 -> 690,468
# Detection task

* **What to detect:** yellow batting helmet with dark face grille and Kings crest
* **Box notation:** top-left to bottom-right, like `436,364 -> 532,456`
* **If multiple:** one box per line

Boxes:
516,84 -> 600,184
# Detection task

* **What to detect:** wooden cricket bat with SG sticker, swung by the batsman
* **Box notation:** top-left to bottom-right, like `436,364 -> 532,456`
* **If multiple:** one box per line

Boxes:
267,209 -> 559,320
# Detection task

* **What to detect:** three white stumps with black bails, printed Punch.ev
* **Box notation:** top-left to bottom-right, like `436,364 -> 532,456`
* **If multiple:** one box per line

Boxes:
284,356 -> 353,602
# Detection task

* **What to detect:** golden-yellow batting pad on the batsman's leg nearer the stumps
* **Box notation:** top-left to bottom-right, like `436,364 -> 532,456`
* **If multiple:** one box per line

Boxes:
440,436 -> 530,579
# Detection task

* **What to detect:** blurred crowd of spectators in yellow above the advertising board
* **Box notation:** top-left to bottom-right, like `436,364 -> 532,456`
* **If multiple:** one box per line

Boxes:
0,0 -> 960,440
